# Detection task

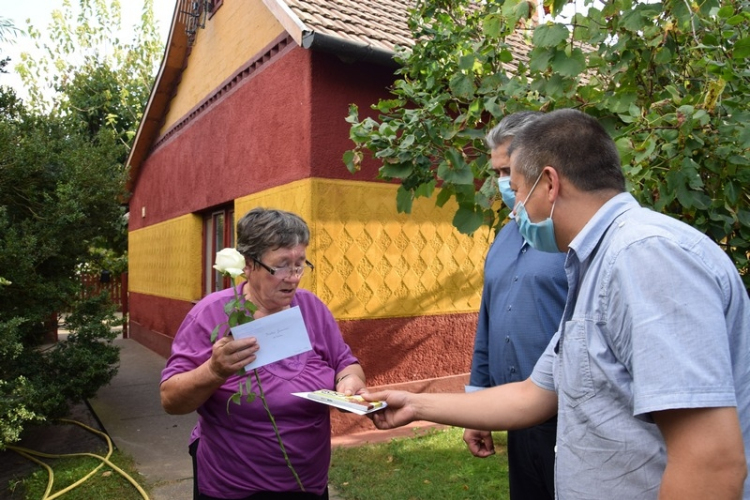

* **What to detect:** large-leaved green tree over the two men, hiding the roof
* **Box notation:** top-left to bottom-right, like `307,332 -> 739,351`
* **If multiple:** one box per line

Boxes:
344,0 -> 750,287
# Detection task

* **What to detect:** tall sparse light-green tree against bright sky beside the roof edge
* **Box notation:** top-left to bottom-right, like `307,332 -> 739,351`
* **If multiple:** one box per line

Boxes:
16,0 -> 163,148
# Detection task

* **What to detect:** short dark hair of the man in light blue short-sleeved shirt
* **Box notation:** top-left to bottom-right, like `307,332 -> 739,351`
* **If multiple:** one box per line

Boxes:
508,109 -> 625,192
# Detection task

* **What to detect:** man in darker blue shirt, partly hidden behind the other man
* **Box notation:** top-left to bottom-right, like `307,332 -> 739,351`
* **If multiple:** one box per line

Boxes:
464,111 -> 568,500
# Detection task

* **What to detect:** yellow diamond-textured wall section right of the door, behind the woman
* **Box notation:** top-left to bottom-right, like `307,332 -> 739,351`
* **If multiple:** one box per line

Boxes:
235,179 -> 490,320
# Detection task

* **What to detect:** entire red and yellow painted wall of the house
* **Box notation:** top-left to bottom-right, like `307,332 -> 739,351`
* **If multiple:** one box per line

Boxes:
129,0 -> 489,433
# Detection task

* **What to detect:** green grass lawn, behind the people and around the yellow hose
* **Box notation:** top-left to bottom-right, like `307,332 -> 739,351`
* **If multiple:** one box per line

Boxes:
8,428 -> 509,500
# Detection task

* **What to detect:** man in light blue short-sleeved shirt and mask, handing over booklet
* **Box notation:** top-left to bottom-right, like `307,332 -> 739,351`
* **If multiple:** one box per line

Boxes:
367,109 -> 750,500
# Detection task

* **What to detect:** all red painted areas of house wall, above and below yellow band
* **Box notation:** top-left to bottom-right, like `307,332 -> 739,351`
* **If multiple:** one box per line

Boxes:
130,46 -> 477,402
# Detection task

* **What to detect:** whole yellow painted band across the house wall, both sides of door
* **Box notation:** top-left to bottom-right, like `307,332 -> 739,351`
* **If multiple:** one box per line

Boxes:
129,179 -> 490,320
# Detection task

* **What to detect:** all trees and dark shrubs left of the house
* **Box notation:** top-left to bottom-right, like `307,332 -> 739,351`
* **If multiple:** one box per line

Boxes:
0,0 -> 161,449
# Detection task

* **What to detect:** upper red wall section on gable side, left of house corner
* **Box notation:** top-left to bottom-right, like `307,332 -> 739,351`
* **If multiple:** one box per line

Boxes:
130,47 -> 311,231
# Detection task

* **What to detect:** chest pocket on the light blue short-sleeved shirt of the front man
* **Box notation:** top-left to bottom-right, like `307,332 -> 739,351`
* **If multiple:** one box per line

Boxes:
556,320 -> 595,407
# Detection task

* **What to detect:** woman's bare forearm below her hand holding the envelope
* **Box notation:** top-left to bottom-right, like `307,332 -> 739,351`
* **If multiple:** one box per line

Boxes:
160,361 -> 226,415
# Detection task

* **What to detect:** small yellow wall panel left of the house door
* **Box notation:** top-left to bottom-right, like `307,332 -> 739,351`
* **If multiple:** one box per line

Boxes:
128,215 -> 203,301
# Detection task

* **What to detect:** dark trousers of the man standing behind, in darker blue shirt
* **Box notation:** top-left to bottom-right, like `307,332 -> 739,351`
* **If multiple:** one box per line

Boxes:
508,417 -> 557,500
